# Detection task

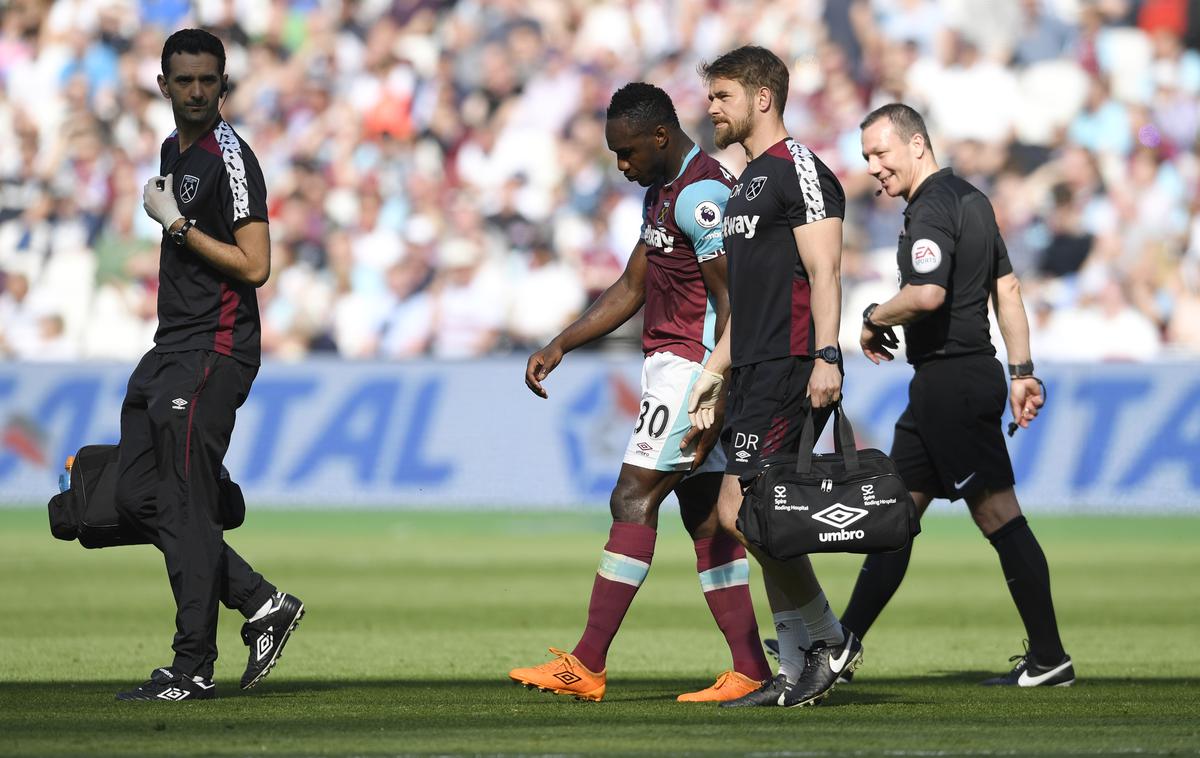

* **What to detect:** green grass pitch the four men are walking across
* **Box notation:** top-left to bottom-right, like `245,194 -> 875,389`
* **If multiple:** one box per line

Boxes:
0,510 -> 1200,756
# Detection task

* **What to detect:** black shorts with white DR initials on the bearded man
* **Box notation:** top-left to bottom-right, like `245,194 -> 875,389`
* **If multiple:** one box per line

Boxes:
721,356 -> 832,476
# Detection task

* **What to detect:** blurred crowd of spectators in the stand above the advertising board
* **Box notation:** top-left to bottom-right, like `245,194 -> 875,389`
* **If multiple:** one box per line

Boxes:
0,0 -> 1200,361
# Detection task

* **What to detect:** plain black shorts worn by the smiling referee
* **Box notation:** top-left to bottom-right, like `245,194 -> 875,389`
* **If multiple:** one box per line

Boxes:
892,355 -> 1014,500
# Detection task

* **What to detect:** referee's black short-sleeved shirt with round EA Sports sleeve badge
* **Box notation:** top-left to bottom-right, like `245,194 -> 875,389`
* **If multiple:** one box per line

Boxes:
896,168 -> 1013,366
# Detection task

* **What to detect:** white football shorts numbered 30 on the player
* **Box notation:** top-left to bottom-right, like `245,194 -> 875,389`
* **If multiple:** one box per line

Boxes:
625,353 -> 725,474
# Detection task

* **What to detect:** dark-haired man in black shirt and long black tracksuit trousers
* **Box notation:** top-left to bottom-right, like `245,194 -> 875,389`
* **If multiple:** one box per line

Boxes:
116,29 -> 304,700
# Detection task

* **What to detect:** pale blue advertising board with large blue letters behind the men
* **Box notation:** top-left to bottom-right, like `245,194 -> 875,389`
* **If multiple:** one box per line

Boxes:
0,354 -> 1200,512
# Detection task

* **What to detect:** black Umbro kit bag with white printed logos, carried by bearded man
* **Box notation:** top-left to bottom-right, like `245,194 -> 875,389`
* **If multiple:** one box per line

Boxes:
738,403 -> 920,560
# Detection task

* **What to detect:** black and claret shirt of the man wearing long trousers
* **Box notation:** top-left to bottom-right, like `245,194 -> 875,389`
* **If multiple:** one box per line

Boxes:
154,119 -> 266,366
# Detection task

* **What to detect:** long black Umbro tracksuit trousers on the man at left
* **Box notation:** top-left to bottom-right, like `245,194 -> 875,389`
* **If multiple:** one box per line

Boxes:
116,350 -> 275,679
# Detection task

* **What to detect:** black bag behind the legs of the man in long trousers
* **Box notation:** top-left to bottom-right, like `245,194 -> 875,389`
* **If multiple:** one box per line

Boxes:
47,445 -> 246,548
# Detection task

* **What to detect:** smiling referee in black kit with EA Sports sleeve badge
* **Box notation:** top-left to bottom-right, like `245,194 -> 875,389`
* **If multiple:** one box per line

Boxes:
841,103 -> 1075,687
